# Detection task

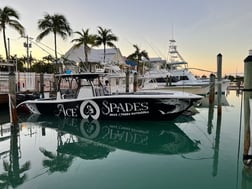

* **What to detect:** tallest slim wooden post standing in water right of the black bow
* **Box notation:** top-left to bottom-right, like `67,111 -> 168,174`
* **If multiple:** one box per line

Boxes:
217,54 -> 222,114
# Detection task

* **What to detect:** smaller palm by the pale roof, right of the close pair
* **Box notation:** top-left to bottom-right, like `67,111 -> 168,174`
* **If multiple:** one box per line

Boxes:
96,26 -> 118,62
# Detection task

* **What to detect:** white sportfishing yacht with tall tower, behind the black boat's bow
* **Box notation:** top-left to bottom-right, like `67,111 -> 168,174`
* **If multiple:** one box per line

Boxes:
142,40 -> 230,96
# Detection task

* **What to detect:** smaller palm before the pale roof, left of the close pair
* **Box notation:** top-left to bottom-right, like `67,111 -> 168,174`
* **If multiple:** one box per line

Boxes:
72,29 -> 96,72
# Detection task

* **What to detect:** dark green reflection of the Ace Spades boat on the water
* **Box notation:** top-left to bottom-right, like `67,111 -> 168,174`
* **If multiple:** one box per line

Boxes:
27,115 -> 199,159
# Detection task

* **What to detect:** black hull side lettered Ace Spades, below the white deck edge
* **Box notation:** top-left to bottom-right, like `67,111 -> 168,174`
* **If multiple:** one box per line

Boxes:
18,96 -> 199,120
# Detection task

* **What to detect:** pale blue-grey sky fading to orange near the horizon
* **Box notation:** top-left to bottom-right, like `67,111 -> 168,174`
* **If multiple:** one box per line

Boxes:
0,0 -> 252,75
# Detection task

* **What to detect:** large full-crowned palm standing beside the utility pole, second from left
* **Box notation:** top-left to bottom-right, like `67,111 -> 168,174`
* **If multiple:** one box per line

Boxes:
37,14 -> 72,71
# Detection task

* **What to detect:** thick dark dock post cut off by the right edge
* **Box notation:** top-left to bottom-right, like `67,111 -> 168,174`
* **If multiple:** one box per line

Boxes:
243,50 -> 252,166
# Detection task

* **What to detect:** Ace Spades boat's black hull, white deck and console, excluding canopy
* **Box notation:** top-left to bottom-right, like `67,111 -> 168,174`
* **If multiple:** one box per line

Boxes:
17,74 -> 202,120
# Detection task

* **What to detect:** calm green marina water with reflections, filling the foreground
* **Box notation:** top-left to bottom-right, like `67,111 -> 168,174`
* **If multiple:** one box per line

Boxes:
0,91 -> 252,189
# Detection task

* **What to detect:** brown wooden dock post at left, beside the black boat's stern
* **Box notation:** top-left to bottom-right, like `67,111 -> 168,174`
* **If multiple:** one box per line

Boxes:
8,72 -> 18,127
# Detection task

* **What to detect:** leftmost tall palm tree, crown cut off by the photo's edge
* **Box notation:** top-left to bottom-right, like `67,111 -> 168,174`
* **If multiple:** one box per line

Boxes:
0,7 -> 24,61
